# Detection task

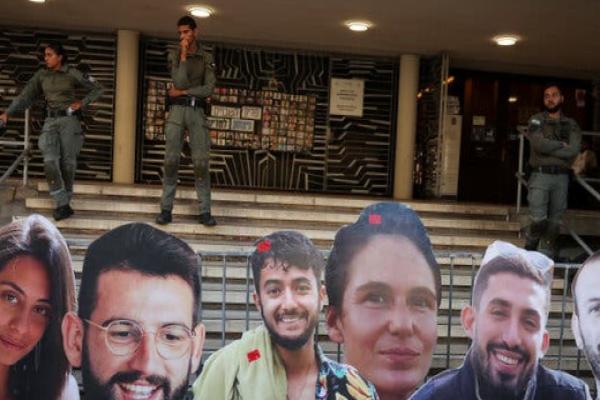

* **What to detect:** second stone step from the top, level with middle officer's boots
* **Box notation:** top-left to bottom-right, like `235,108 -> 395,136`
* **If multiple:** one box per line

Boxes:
26,197 -> 520,232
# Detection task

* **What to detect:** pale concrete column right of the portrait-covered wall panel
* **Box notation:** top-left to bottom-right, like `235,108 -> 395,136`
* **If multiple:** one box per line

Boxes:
394,54 -> 419,200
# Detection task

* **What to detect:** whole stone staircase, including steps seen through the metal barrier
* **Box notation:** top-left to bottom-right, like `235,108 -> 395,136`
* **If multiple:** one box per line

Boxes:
19,182 -> 591,380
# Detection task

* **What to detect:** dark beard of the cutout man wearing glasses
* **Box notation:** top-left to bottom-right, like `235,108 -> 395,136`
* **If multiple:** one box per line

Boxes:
81,344 -> 191,400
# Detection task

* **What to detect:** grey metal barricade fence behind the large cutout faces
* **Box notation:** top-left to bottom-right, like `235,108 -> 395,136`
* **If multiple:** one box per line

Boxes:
192,253 -> 589,375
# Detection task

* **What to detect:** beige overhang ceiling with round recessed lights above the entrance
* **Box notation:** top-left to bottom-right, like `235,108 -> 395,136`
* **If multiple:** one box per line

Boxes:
0,0 -> 600,78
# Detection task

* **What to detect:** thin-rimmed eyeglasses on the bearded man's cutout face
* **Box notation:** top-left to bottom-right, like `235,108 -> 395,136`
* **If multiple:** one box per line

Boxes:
85,319 -> 194,360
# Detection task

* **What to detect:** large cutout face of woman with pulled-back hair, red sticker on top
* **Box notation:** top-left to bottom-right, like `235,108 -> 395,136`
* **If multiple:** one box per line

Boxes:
325,203 -> 441,399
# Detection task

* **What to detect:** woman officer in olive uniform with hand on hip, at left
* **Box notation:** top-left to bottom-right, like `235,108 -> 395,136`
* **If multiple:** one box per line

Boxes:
0,43 -> 102,221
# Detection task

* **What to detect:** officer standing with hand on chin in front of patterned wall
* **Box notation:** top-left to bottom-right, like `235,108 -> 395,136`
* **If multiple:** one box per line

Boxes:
156,16 -> 217,226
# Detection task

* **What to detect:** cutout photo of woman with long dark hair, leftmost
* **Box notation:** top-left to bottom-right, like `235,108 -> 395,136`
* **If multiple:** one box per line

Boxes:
0,214 -> 79,400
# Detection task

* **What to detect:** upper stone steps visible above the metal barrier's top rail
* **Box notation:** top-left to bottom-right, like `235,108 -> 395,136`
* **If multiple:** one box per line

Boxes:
25,182 -> 523,252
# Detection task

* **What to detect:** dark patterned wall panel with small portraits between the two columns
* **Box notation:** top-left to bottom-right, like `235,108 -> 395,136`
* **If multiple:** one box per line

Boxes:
137,38 -> 397,195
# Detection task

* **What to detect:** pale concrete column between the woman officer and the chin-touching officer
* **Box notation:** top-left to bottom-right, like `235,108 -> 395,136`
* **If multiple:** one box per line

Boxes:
113,30 -> 140,183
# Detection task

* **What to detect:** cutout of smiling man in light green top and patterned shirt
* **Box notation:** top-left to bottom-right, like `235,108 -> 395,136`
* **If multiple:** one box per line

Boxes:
194,231 -> 378,400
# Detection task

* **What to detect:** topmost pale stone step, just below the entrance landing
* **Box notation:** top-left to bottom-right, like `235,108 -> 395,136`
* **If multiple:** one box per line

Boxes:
37,181 -> 510,219
